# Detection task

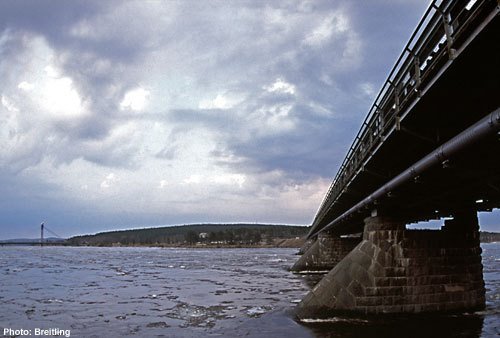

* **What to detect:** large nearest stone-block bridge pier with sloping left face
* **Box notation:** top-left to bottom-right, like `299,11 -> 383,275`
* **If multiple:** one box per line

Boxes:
296,212 -> 485,319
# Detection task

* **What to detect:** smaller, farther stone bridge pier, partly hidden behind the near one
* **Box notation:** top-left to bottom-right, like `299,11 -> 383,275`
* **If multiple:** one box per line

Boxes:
291,232 -> 360,272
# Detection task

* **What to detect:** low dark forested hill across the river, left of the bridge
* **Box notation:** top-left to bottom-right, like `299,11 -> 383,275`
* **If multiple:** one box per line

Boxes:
68,224 -> 309,246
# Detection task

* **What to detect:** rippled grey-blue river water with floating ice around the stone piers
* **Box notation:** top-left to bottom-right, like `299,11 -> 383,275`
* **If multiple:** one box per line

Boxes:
0,244 -> 500,338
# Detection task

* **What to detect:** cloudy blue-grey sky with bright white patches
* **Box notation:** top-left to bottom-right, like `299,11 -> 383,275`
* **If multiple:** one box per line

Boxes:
0,0 -> 500,239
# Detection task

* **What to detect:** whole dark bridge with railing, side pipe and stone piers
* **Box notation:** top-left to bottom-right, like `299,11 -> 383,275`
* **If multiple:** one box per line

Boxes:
292,0 -> 500,319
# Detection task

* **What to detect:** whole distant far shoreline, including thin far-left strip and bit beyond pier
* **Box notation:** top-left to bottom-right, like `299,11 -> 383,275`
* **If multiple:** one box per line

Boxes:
0,224 -> 500,249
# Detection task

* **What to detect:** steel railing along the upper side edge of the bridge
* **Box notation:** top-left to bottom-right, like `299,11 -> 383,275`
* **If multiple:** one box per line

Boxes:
311,0 -> 498,233
